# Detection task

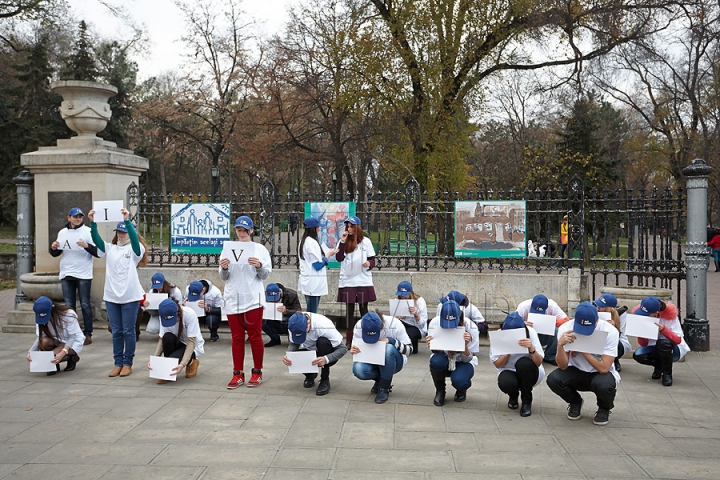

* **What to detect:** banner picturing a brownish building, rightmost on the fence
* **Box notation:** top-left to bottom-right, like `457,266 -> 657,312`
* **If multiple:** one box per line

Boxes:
455,200 -> 526,258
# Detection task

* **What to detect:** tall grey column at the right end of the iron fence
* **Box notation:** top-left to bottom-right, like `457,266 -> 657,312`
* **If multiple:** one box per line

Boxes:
682,158 -> 713,352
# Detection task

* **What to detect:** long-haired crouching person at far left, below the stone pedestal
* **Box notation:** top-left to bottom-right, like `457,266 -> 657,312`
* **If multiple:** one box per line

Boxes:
27,297 -> 85,375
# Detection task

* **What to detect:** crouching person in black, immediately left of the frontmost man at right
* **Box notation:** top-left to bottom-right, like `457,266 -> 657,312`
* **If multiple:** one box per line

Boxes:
490,312 -> 545,417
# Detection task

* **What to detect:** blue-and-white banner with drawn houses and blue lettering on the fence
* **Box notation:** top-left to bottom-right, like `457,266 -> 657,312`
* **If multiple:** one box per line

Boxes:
170,203 -> 230,253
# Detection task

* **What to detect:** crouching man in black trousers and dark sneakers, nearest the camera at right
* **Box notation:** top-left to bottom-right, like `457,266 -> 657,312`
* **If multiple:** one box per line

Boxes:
547,302 -> 620,425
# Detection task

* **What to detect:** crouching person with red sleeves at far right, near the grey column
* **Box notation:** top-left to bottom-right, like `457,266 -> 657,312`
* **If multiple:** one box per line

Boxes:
633,297 -> 690,387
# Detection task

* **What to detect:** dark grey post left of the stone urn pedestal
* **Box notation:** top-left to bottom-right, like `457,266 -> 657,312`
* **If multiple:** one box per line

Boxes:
13,170 -> 35,310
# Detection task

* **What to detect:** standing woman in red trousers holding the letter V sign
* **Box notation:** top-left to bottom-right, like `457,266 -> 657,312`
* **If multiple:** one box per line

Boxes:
220,215 -> 272,390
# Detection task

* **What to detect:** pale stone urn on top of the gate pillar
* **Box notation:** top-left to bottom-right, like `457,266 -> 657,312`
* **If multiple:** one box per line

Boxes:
50,80 -> 118,138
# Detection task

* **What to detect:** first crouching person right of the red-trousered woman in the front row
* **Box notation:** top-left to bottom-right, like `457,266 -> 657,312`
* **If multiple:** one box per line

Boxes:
283,312 -> 347,396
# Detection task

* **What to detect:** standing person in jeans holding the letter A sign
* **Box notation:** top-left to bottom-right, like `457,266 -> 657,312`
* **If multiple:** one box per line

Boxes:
50,207 -> 98,345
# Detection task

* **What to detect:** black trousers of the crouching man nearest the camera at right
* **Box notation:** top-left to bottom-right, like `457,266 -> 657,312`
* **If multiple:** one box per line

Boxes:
547,366 -> 617,410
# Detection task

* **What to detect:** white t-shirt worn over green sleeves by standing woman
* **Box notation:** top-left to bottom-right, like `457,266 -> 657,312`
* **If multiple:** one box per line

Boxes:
98,242 -> 145,303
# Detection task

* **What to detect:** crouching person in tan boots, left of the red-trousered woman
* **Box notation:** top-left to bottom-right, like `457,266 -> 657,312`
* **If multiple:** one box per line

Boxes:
148,298 -> 205,384
